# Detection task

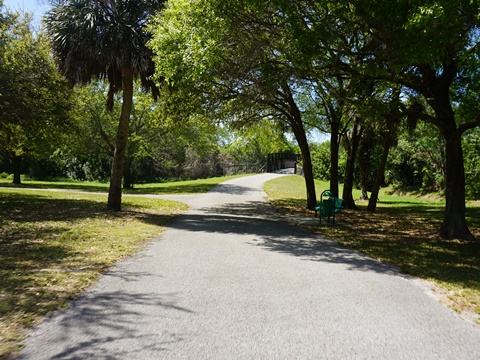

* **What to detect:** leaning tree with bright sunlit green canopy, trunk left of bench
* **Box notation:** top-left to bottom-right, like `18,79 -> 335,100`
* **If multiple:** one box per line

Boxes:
151,0 -> 316,209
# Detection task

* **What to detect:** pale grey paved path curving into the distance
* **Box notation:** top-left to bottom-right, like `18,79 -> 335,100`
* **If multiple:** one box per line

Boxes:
17,174 -> 480,360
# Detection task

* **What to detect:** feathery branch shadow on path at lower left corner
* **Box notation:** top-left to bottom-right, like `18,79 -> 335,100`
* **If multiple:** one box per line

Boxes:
18,282 -> 193,360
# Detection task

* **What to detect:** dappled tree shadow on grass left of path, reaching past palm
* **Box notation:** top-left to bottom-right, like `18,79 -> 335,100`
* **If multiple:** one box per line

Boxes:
0,192 -> 180,348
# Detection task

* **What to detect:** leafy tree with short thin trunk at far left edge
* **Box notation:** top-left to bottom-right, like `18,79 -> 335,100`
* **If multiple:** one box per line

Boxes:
0,13 -> 70,184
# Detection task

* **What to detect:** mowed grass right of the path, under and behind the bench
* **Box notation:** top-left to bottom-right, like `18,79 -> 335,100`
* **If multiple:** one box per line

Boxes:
265,176 -> 480,324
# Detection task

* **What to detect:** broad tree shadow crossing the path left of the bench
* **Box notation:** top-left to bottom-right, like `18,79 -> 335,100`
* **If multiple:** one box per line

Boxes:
171,201 -> 397,274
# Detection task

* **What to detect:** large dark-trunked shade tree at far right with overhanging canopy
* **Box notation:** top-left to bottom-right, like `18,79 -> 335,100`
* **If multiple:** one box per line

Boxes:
270,0 -> 480,239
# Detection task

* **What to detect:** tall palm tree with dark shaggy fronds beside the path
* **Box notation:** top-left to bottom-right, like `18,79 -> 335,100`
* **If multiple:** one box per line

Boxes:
44,0 -> 165,211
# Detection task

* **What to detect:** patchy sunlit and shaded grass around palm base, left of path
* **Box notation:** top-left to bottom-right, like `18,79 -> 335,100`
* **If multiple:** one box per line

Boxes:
0,188 -> 187,359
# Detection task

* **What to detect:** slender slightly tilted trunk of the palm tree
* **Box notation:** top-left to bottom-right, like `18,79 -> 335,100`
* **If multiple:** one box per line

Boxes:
107,68 -> 133,211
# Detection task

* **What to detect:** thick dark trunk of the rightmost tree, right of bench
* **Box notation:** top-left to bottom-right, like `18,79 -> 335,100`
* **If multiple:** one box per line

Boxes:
440,131 -> 474,240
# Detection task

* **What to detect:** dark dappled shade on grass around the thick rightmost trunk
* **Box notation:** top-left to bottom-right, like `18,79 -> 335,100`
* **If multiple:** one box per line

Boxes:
320,204 -> 480,288
